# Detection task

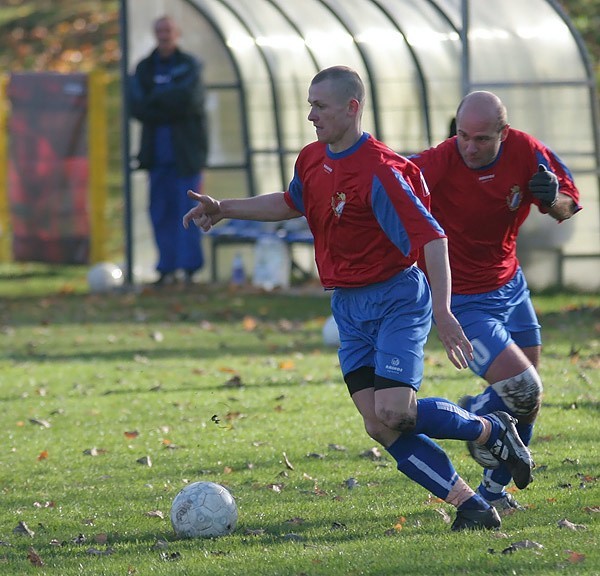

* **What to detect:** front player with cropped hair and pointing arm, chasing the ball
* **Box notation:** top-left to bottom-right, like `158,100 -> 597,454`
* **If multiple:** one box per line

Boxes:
183,66 -> 533,530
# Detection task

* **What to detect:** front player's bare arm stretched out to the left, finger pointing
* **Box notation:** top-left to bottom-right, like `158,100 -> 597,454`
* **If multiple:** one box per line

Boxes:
183,190 -> 302,232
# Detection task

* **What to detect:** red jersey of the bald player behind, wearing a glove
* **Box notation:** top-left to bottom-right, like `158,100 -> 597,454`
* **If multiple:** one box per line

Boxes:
410,128 -> 579,294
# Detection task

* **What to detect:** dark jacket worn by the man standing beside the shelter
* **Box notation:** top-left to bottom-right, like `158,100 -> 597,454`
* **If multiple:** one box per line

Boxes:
129,49 -> 208,176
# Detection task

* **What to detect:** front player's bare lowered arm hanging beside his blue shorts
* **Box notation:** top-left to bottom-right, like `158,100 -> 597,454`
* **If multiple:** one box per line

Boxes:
424,238 -> 473,368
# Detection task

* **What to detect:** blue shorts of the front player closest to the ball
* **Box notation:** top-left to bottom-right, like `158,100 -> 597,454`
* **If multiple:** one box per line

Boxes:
331,266 -> 431,392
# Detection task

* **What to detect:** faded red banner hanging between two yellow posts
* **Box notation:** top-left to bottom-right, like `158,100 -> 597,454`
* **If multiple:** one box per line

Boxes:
7,73 -> 90,264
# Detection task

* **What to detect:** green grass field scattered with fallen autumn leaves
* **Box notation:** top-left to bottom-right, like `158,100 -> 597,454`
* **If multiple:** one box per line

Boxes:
0,265 -> 600,576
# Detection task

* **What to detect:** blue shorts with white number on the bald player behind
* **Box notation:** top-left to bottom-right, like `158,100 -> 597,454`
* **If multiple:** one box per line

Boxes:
451,268 -> 542,377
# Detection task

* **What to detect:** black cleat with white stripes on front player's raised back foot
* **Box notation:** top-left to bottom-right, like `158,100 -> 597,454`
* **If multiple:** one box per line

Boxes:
480,412 -> 535,490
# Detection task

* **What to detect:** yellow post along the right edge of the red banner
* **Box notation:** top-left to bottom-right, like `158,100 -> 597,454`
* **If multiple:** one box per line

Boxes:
88,70 -> 108,263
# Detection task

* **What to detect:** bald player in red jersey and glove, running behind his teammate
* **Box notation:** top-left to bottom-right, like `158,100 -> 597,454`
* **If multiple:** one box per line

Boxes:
410,91 -> 580,509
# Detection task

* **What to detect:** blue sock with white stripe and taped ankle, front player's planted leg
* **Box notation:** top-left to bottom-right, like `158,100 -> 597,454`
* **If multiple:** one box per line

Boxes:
387,434 -> 489,510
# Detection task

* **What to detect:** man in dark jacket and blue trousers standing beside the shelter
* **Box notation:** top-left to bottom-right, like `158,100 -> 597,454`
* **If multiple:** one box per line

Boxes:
130,16 -> 208,285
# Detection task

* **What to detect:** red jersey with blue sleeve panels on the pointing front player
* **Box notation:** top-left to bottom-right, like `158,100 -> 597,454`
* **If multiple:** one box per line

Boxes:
285,133 -> 445,288
